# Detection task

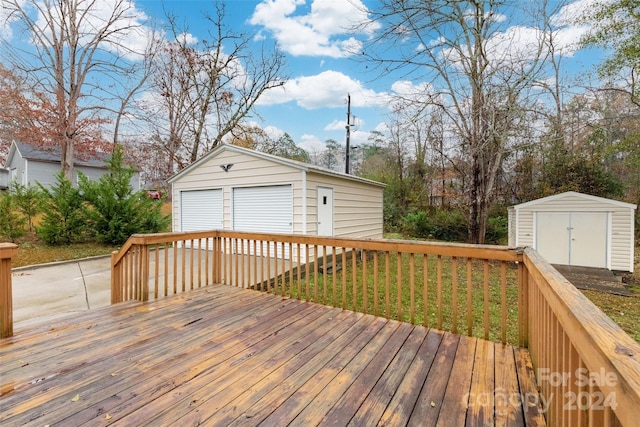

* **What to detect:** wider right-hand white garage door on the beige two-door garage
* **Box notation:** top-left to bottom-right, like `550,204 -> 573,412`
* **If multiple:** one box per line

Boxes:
233,185 -> 293,233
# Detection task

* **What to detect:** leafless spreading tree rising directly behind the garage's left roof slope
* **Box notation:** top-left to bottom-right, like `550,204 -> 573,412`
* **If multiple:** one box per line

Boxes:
149,3 -> 284,176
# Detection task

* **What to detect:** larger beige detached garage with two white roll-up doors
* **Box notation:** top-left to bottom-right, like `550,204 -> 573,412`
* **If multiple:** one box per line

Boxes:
169,144 -> 384,242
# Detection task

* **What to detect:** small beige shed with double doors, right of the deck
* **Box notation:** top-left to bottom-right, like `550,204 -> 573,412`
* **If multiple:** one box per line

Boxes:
509,191 -> 636,272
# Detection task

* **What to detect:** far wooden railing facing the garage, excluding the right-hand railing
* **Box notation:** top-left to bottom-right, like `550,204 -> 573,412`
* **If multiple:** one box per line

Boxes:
112,231 -> 526,344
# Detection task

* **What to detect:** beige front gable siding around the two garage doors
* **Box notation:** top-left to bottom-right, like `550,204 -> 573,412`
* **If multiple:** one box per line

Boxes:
172,151 -> 302,233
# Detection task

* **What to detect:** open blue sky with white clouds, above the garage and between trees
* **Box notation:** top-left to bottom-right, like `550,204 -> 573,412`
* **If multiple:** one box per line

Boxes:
0,0 -> 601,156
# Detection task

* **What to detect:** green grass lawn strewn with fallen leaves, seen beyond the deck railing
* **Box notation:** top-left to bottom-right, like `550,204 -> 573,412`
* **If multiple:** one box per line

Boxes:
6,221 -> 640,344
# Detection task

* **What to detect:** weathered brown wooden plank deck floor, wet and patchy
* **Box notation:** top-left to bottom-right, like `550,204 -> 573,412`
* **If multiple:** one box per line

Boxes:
0,285 -> 544,426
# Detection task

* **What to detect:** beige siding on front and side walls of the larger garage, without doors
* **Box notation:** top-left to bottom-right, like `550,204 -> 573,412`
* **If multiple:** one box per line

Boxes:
169,145 -> 384,244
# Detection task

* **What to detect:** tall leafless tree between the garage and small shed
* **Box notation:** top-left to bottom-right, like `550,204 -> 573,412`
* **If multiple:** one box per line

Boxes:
358,0 -> 547,243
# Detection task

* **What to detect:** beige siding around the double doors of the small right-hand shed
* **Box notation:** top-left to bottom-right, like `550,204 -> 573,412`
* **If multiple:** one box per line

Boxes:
514,194 -> 634,271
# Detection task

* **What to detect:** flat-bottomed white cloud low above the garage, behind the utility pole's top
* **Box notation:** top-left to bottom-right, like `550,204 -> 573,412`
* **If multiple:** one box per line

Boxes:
258,70 -> 386,110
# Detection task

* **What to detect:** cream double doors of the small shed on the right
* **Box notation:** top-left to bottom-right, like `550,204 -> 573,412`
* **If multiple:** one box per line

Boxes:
536,212 -> 609,268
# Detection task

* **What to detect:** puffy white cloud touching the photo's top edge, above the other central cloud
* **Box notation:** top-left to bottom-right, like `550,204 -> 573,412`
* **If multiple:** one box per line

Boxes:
249,0 -> 378,58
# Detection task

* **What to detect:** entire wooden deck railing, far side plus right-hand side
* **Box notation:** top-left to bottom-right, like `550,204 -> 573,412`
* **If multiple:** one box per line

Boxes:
106,231 -> 640,426
